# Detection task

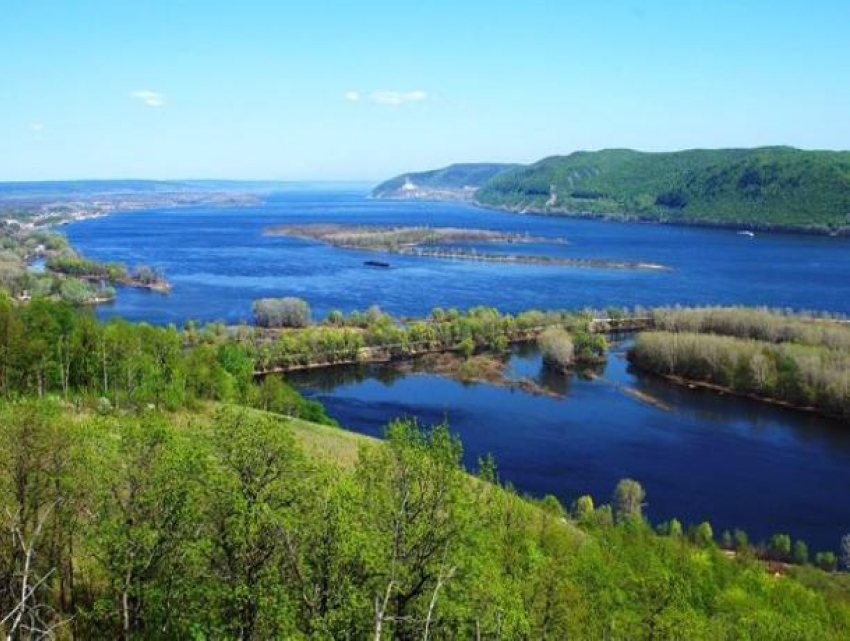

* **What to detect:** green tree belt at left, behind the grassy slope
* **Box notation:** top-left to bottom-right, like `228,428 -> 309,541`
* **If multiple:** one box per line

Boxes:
0,291 -> 333,423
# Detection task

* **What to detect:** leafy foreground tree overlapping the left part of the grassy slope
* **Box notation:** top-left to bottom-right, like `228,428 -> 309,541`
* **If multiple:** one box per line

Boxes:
202,409 -> 308,639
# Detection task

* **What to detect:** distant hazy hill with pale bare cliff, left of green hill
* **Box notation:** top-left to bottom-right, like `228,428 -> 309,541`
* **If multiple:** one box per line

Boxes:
372,163 -> 520,200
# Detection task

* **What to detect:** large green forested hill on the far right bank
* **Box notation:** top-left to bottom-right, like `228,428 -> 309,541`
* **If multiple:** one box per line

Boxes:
475,147 -> 850,232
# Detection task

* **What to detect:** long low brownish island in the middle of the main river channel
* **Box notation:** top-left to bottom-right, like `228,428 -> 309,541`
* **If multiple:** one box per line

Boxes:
265,223 -> 669,270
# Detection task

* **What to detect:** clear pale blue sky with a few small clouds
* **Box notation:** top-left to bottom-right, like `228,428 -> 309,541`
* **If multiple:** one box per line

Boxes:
0,0 -> 850,181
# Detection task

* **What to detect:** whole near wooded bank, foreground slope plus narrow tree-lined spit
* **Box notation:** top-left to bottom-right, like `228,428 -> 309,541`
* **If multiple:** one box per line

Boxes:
0,295 -> 850,639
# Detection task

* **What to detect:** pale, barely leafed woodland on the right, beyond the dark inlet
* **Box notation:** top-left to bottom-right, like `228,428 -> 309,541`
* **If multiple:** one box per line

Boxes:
629,308 -> 850,419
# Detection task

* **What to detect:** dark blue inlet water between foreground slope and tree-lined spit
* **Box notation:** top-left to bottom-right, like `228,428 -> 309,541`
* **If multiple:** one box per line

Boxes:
290,344 -> 850,549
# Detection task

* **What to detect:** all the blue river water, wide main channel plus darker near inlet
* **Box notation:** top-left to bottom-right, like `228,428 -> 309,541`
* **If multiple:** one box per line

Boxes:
68,189 -> 850,549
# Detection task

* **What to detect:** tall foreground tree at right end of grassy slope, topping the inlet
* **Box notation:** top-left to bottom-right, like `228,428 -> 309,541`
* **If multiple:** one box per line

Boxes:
356,421 -> 469,639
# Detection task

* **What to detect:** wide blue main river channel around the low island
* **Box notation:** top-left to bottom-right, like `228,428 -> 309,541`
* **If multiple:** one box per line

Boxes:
68,191 -> 850,324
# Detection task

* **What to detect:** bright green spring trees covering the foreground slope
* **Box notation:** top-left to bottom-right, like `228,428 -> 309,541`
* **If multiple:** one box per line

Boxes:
0,400 -> 850,639
